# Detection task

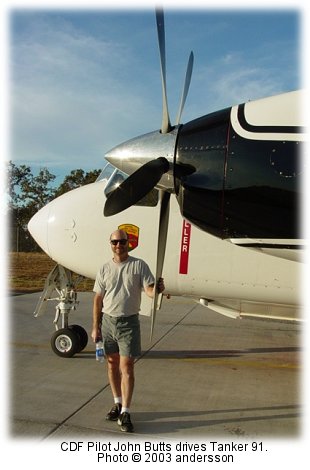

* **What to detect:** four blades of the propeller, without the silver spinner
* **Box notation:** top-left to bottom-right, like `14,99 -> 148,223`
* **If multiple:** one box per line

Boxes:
104,8 -> 194,339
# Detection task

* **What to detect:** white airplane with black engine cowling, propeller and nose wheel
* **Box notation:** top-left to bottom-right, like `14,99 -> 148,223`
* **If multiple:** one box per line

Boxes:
28,10 -> 306,357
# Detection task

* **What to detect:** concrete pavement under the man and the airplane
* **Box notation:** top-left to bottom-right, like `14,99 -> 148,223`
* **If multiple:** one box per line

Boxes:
7,293 -> 303,442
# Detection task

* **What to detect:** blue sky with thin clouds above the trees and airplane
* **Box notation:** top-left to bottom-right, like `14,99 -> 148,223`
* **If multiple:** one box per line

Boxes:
7,2 -> 303,184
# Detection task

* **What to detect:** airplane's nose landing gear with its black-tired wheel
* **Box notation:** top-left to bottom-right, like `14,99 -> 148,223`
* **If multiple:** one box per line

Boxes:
34,264 -> 88,357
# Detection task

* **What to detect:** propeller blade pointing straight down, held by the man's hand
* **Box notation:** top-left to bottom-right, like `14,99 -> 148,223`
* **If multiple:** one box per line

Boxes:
150,190 -> 170,340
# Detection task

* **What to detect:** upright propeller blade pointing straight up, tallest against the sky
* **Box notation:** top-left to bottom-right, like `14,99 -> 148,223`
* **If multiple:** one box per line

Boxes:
156,9 -> 171,134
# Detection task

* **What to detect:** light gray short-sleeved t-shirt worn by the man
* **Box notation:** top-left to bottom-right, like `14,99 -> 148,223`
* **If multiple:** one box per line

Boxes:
93,256 -> 155,317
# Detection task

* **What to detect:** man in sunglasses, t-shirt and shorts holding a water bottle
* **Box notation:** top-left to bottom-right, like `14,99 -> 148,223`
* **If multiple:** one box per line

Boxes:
91,230 -> 165,432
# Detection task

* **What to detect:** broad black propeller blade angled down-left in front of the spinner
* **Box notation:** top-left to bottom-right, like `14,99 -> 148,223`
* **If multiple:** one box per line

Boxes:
103,157 -> 169,217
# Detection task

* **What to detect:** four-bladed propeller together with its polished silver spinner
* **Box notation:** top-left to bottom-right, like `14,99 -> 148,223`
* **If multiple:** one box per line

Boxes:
104,9 -> 194,339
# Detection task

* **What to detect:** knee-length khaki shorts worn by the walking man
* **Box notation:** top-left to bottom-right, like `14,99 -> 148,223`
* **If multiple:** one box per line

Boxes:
102,313 -> 141,357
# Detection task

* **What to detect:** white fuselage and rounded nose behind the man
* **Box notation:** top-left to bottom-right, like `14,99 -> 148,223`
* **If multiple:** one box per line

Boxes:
29,174 -> 300,317
